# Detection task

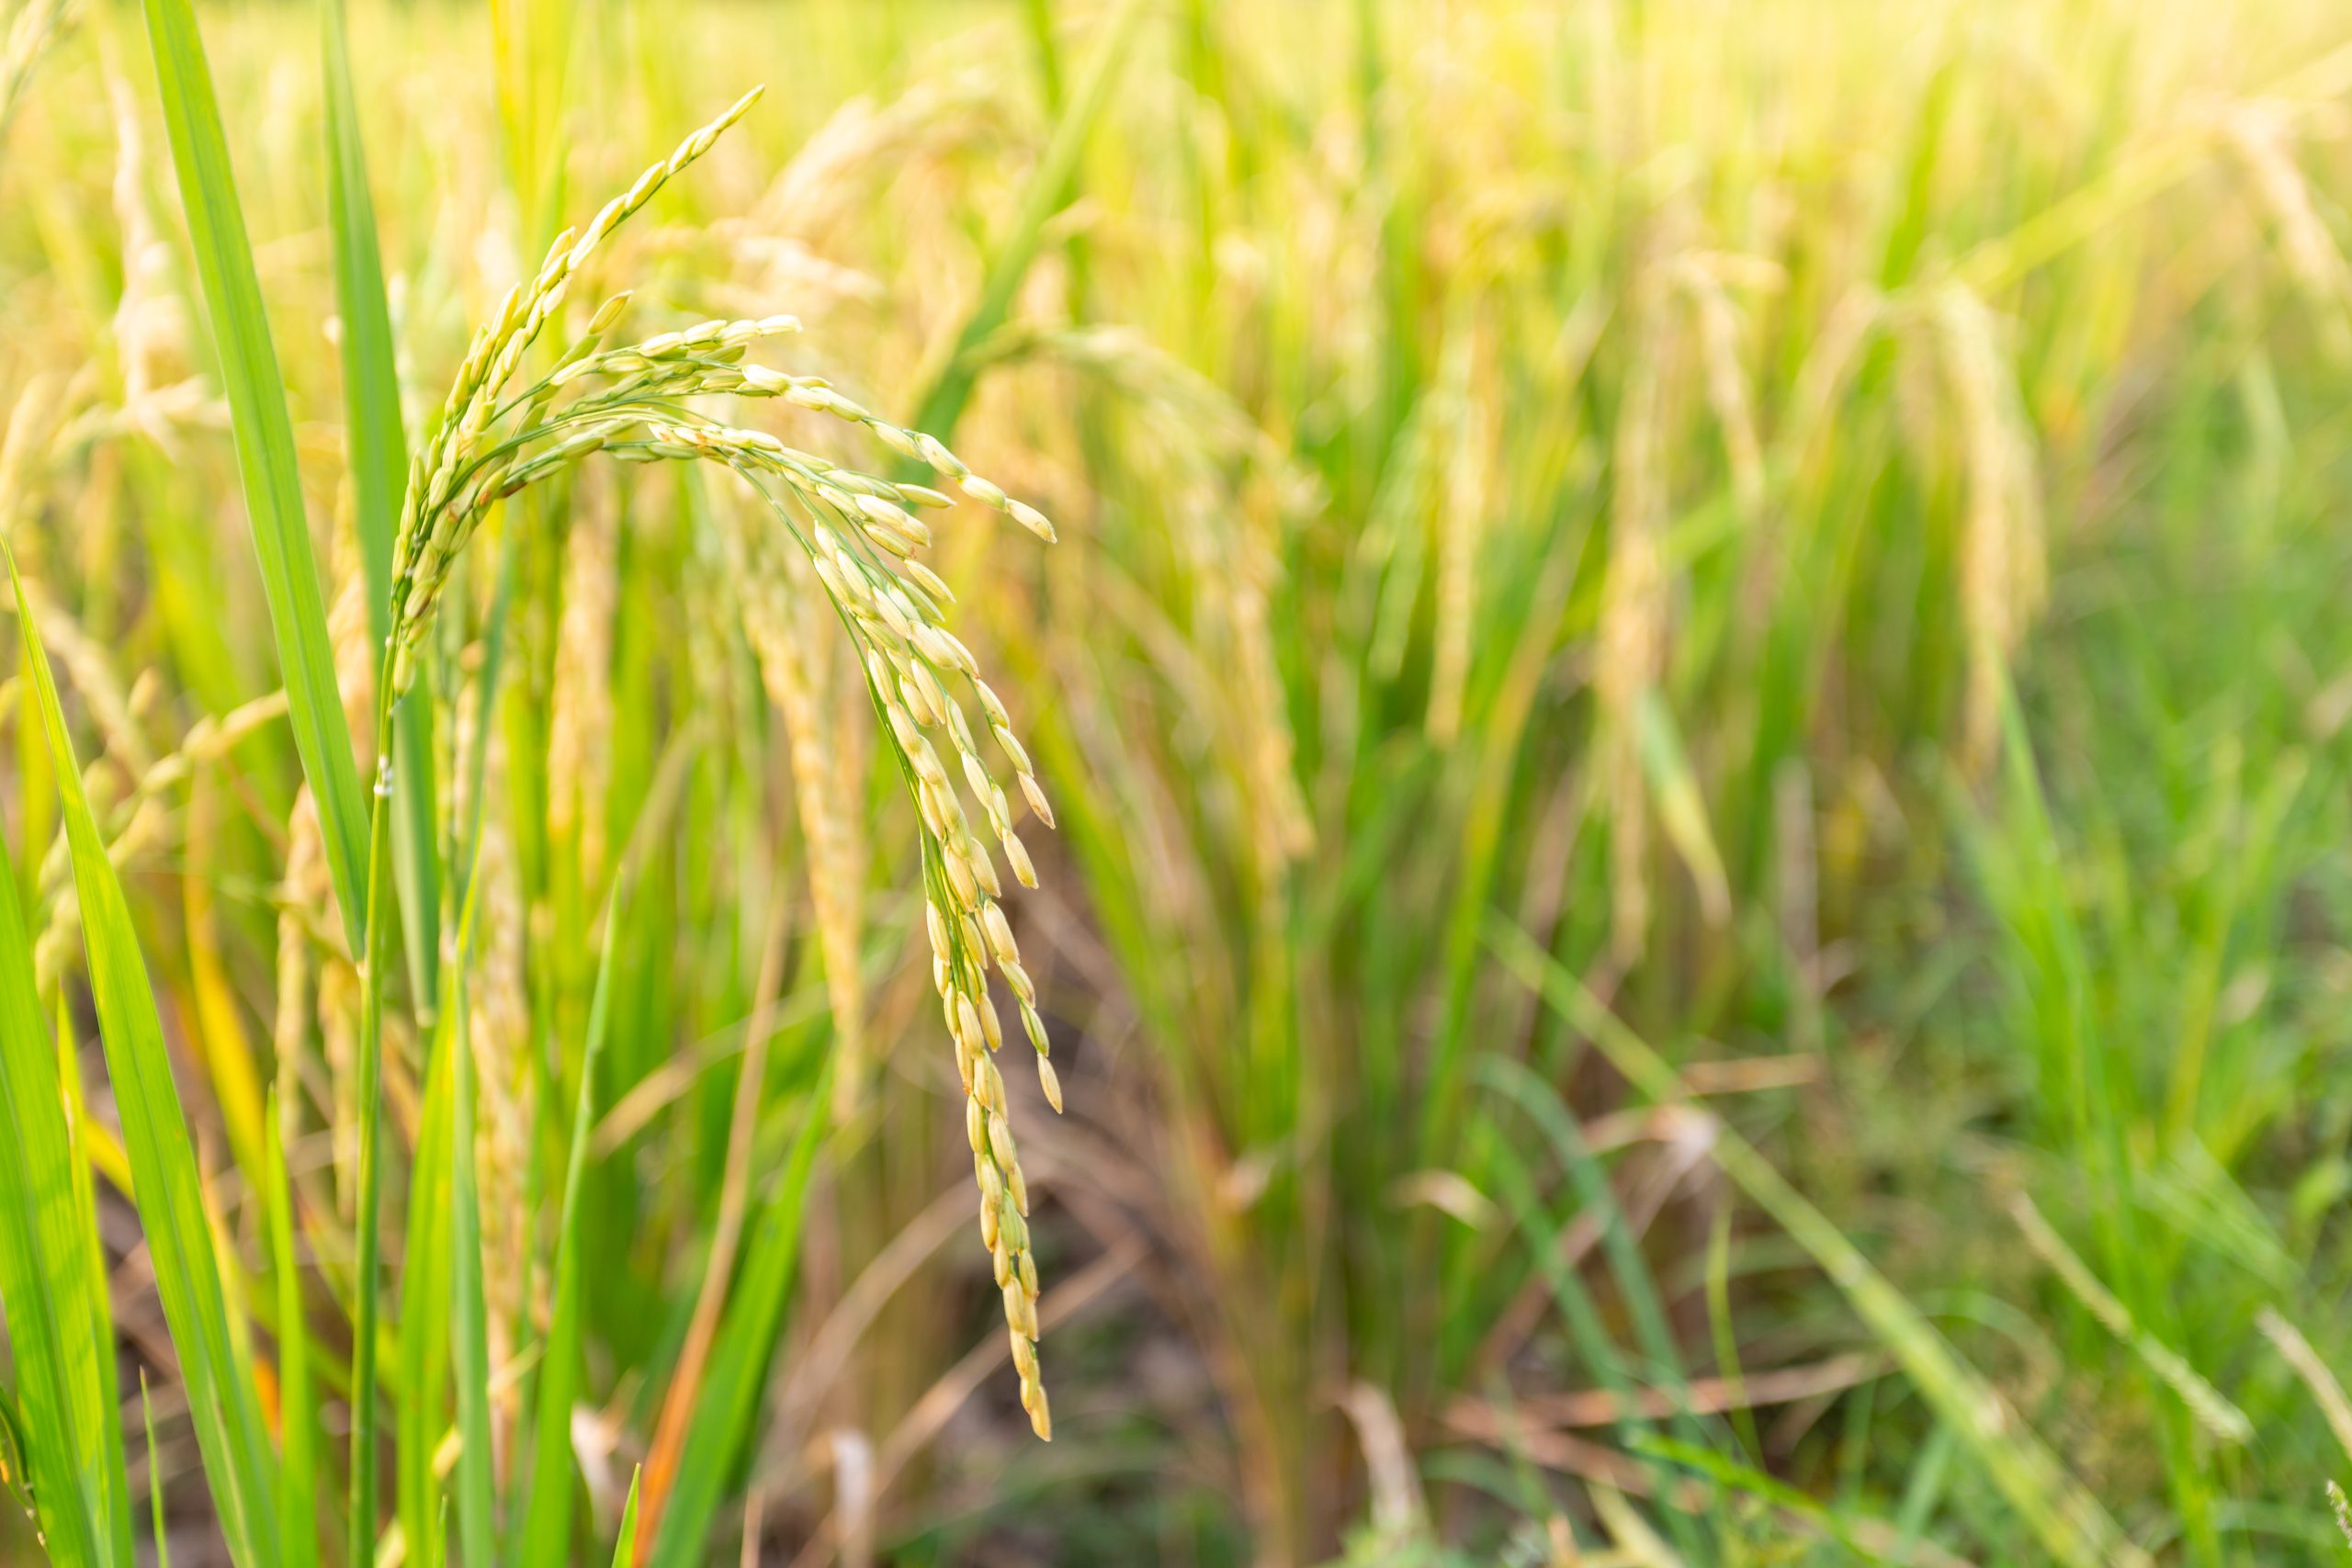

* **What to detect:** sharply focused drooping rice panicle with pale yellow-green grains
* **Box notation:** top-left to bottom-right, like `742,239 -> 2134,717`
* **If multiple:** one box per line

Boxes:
390,92 -> 1061,1437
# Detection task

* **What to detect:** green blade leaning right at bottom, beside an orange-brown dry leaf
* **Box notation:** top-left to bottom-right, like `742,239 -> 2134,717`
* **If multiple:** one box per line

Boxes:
651,1081 -> 832,1568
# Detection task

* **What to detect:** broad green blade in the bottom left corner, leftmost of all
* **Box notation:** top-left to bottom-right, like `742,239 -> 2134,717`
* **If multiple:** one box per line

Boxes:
0,799 -> 131,1568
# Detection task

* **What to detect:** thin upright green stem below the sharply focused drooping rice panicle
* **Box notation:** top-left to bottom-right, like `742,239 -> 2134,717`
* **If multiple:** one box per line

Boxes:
344,667 -> 400,1568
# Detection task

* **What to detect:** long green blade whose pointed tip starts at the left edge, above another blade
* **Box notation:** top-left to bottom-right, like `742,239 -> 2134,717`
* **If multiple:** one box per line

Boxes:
0,547 -> 277,1568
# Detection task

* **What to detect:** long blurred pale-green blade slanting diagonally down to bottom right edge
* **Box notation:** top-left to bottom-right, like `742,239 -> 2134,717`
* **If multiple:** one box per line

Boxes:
1488,921 -> 2150,1568
